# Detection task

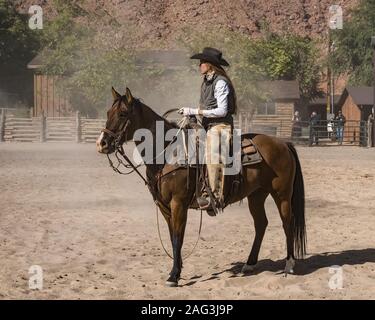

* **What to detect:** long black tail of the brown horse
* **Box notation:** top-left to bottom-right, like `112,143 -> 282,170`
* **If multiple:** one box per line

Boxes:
287,142 -> 307,258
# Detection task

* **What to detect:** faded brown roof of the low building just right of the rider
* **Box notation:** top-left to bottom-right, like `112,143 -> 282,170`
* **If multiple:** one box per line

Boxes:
260,80 -> 300,100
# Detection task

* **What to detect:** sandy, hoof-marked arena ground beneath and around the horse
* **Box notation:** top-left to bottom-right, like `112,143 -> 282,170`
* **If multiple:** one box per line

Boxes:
0,143 -> 375,299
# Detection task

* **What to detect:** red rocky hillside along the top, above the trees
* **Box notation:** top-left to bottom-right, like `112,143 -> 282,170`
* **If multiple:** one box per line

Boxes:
16,0 -> 358,48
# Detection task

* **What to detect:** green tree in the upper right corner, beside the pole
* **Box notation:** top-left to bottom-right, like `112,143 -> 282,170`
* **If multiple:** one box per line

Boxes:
329,0 -> 375,86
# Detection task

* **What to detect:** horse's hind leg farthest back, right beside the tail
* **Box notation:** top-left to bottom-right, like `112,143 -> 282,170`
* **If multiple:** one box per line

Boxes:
272,193 -> 295,273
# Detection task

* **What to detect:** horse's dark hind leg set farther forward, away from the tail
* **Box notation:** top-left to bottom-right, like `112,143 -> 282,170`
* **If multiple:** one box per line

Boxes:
242,189 -> 269,273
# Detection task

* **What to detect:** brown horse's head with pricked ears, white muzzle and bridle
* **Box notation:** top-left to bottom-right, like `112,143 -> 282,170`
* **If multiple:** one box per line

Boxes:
96,88 -> 138,154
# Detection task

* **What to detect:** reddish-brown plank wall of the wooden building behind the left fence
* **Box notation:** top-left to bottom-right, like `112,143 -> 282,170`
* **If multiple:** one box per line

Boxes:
27,53 -> 74,118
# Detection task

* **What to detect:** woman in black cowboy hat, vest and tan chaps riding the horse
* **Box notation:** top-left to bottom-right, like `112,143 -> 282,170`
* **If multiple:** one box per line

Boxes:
180,47 -> 236,215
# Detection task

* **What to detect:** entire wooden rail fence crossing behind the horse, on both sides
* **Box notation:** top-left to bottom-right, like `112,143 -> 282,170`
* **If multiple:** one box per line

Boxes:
0,110 -> 373,146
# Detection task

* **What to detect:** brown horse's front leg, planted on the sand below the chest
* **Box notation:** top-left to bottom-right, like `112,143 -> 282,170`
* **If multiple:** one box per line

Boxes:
166,199 -> 187,287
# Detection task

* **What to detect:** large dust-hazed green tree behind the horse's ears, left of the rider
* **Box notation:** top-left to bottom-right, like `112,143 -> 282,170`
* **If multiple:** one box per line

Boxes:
41,0 -> 191,116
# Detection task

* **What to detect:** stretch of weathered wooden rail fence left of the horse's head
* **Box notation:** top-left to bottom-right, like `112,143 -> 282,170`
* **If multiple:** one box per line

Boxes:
0,111 -> 105,143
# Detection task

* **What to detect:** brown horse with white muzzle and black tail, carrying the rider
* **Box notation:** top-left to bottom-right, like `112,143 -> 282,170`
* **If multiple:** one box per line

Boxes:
97,88 -> 306,286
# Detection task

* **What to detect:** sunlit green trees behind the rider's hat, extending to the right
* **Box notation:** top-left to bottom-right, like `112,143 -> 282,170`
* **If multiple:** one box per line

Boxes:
179,26 -> 321,108
